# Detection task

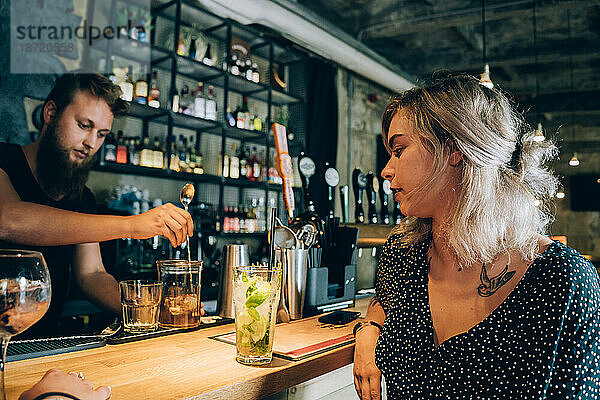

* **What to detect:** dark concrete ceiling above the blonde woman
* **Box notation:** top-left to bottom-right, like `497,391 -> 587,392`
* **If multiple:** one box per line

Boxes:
297,0 -> 600,152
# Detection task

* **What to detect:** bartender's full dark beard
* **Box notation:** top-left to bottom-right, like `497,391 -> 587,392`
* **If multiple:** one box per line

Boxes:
36,122 -> 96,199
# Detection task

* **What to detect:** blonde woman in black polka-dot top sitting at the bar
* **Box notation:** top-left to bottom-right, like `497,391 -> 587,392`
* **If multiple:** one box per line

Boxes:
354,75 -> 600,399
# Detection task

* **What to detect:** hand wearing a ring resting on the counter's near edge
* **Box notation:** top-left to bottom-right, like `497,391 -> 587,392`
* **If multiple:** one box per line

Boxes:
19,369 -> 110,400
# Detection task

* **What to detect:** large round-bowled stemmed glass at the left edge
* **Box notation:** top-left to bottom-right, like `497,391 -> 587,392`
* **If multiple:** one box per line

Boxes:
0,250 -> 52,400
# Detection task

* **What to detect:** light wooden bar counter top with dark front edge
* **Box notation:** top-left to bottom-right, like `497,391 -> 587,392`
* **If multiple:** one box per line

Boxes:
5,298 -> 369,400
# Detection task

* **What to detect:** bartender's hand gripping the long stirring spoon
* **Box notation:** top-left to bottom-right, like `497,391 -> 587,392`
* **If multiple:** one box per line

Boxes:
128,203 -> 194,247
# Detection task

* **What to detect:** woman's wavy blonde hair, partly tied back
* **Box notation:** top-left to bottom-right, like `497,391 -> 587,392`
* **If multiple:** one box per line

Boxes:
382,74 -> 558,265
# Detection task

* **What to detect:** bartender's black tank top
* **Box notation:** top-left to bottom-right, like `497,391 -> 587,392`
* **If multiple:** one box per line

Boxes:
0,143 -> 96,339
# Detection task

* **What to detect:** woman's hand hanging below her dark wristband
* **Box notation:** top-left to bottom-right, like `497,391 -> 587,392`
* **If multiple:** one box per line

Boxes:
354,325 -> 381,400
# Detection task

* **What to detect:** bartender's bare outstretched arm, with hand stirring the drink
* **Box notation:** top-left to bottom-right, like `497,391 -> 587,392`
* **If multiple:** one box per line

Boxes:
0,169 -> 194,246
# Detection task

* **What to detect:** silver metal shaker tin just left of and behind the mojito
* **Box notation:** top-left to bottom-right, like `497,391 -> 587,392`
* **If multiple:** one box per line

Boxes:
217,244 -> 249,318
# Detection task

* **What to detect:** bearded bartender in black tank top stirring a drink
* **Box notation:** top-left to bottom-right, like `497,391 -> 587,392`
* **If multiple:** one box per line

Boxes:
0,71 -> 193,337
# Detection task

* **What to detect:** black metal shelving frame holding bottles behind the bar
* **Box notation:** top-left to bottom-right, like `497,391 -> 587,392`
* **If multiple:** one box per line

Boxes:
84,0 -> 307,237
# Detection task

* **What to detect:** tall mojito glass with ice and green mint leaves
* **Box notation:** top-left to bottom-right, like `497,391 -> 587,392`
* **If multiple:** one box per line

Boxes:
233,265 -> 281,365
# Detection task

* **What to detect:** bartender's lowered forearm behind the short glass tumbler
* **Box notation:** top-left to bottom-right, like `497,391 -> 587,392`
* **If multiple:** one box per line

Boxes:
73,243 -> 121,314
